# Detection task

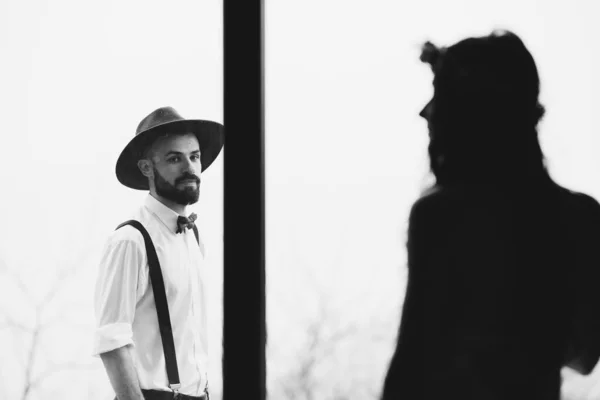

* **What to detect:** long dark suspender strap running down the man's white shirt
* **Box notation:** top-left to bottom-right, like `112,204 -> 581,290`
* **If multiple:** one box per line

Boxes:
117,220 -> 180,391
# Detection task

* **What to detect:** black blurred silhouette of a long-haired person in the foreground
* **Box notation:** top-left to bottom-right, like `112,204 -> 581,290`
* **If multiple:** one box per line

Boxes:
382,31 -> 600,400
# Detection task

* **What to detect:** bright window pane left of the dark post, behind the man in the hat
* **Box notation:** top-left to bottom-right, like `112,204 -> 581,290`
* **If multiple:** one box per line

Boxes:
0,0 -> 223,400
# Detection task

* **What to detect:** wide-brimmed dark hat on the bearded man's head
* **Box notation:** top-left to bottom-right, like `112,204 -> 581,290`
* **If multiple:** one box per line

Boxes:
116,107 -> 224,190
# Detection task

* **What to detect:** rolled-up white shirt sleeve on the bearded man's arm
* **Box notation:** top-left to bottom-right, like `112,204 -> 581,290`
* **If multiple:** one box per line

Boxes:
93,233 -> 146,356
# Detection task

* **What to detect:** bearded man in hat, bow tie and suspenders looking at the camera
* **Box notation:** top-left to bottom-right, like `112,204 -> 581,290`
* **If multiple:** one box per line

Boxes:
94,107 -> 224,400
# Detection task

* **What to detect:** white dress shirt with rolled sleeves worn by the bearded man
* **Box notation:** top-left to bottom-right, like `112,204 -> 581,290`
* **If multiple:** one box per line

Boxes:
93,195 -> 208,396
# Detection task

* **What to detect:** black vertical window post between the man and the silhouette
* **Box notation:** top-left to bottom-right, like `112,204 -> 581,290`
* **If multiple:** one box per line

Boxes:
223,0 -> 266,400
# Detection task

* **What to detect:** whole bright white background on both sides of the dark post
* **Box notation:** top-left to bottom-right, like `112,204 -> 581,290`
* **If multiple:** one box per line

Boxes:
0,0 -> 600,400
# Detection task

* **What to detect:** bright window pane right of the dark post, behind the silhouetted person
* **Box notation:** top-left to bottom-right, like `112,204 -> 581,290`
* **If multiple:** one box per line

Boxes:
265,0 -> 600,400
